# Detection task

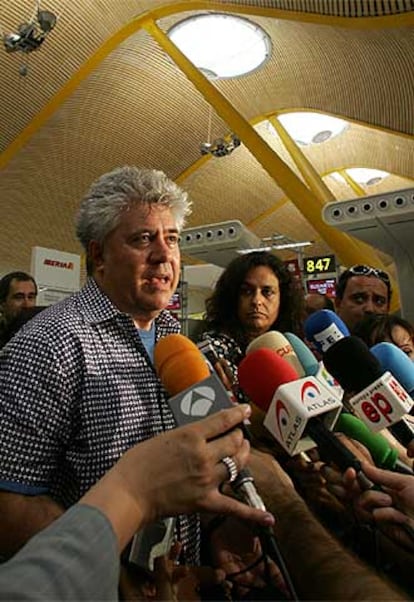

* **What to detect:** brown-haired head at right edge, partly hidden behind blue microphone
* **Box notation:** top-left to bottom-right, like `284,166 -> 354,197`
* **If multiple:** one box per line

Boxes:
353,314 -> 414,361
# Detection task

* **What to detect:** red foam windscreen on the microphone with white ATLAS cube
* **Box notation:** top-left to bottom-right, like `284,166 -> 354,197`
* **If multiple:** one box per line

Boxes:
238,349 -> 298,412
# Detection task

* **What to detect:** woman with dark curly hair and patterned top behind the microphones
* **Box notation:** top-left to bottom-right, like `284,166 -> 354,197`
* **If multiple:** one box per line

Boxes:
200,251 -> 303,399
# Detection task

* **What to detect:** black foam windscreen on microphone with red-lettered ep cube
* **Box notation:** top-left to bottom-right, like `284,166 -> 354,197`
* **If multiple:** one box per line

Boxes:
323,336 -> 384,393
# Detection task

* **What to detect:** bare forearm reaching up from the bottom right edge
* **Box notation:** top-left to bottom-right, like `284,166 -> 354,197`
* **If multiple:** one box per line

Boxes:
265,488 -> 404,600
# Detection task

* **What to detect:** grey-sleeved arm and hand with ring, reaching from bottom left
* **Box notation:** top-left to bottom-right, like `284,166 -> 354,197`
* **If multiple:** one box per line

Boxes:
0,406 -> 274,602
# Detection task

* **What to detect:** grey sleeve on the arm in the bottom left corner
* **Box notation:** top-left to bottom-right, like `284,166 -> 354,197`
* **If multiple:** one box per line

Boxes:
0,504 -> 119,602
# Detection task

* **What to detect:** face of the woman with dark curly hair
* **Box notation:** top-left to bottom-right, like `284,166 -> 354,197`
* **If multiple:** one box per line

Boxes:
237,266 -> 280,339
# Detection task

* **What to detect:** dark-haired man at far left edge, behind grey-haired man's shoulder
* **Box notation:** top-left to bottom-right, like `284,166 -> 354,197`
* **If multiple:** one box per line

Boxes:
0,272 -> 37,347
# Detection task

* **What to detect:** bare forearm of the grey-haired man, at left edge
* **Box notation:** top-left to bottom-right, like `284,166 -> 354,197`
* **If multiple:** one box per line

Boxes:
0,491 -> 65,558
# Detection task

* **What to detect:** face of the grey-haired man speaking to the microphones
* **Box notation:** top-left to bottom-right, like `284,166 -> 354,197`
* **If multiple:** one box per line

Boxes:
91,205 -> 180,328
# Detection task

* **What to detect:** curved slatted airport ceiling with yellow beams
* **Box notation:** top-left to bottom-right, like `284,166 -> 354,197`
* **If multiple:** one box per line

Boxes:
0,0 -> 414,302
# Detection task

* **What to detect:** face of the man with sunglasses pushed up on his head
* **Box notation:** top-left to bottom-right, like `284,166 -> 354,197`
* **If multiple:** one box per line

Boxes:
335,276 -> 390,331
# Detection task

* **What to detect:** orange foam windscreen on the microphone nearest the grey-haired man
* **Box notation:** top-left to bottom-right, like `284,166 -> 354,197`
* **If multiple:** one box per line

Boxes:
154,334 -> 210,396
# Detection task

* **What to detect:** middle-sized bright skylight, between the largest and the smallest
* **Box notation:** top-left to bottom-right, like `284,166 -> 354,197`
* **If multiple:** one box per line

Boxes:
278,111 -> 348,146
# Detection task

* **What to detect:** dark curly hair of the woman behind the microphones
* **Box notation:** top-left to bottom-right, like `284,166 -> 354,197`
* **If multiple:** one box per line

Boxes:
205,251 -> 304,347
